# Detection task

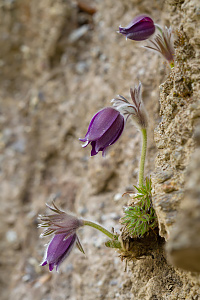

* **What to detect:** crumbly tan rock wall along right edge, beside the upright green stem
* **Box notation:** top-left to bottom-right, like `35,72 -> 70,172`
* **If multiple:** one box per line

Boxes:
154,1 -> 200,272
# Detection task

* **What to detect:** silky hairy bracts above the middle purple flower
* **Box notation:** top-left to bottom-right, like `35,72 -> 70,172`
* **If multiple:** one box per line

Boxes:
111,82 -> 148,129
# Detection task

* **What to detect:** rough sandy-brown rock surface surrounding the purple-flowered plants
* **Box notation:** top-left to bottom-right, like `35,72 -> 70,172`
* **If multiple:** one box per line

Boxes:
0,0 -> 200,300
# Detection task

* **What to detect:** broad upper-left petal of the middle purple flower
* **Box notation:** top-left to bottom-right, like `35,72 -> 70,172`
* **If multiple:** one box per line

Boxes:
80,107 -> 120,142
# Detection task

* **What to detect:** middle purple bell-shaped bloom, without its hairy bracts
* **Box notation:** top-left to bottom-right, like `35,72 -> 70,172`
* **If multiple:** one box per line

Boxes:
79,107 -> 125,156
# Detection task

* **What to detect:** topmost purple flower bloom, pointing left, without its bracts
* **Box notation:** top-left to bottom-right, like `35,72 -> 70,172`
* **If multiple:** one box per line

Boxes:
119,15 -> 155,41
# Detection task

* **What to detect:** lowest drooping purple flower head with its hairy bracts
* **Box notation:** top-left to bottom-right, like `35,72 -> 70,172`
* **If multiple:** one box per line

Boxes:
39,202 -> 84,271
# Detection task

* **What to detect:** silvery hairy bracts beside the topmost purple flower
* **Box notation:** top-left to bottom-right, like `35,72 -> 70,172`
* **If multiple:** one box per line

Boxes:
144,25 -> 175,68
